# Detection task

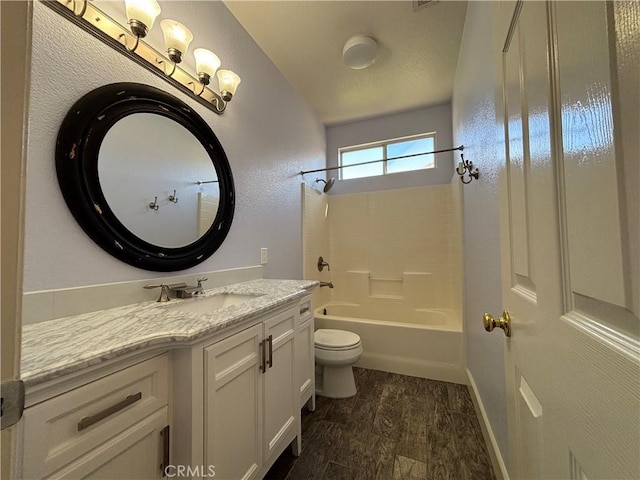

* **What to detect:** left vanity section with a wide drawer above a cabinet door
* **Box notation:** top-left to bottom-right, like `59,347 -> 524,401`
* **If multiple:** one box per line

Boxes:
22,354 -> 169,479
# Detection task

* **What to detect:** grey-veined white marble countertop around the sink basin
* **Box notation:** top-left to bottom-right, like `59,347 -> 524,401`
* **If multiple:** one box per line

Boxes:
21,279 -> 318,388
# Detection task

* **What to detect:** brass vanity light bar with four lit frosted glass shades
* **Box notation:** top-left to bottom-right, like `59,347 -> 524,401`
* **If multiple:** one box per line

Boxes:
41,0 -> 240,115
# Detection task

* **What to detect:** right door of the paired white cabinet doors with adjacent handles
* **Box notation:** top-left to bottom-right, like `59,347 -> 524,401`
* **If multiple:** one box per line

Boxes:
264,309 -> 300,463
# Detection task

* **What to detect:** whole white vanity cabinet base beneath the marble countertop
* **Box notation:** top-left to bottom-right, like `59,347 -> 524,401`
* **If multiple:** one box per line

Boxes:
20,284 -> 314,480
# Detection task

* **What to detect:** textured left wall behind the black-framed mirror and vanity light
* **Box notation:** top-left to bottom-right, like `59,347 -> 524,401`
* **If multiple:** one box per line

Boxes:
24,1 -> 325,292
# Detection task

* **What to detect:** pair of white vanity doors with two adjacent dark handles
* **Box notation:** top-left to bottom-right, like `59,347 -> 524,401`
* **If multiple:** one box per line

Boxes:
204,306 -> 300,479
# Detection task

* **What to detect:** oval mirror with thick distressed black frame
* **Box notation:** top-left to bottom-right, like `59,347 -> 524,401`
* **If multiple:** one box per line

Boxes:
56,83 -> 235,271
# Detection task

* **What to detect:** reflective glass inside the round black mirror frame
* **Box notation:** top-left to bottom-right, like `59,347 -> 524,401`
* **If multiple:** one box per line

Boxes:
98,113 -> 220,248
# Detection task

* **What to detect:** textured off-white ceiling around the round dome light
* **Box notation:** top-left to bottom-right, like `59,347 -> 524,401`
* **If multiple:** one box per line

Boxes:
225,0 -> 467,125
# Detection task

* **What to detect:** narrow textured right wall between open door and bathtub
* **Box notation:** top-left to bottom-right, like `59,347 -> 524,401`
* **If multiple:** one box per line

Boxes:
453,2 -> 508,459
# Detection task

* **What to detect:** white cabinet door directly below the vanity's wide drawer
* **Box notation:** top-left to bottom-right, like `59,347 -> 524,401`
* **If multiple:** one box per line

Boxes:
47,408 -> 172,480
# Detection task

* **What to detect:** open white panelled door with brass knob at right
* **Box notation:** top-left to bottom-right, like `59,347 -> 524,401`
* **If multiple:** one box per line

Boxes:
492,1 -> 640,480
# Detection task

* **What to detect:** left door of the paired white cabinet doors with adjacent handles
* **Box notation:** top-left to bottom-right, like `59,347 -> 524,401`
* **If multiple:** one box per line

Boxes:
204,324 -> 263,480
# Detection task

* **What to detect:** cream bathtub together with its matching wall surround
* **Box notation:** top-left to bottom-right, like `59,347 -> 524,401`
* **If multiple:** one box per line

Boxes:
303,182 -> 466,383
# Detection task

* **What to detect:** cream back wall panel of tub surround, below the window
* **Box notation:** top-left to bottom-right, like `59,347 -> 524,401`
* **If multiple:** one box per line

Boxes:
328,185 -> 462,318
